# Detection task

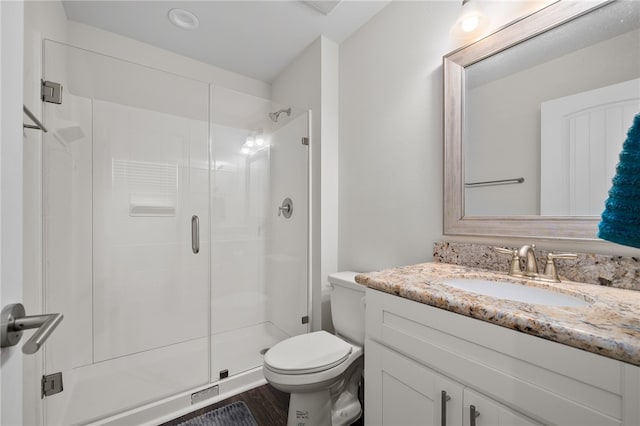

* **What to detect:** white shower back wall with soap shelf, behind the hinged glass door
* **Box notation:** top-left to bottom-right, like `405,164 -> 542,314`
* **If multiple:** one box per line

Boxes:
93,100 -> 209,362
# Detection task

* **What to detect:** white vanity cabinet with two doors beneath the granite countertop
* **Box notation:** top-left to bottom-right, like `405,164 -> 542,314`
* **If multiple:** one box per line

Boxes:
365,289 -> 640,426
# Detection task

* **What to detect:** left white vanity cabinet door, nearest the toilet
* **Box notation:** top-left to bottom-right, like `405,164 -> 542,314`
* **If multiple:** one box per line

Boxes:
365,340 -> 462,426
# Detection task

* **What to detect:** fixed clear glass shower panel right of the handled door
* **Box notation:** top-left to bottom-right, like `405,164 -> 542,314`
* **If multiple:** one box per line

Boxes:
211,87 -> 309,381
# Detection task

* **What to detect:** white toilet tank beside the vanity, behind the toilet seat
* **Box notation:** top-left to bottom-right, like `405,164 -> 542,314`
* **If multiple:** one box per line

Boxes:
329,271 -> 366,345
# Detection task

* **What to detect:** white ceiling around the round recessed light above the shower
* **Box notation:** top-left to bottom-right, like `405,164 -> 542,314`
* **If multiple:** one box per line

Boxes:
63,0 -> 390,82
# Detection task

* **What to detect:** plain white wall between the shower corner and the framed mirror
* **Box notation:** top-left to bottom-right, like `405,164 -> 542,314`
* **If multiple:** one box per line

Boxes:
338,1 -> 460,271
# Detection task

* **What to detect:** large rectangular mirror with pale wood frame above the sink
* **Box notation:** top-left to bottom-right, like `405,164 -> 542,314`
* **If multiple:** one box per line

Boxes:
443,0 -> 640,240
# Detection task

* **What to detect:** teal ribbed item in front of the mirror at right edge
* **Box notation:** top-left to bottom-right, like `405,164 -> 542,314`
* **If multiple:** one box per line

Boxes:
598,113 -> 640,248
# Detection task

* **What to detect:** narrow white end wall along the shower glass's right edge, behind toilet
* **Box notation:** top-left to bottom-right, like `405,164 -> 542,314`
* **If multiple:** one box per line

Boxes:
271,37 -> 338,330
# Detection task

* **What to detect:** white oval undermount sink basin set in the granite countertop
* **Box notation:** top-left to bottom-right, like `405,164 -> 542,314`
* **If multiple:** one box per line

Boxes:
442,278 -> 589,307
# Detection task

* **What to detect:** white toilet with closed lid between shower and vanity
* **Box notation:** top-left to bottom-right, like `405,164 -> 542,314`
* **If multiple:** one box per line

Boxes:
263,272 -> 365,426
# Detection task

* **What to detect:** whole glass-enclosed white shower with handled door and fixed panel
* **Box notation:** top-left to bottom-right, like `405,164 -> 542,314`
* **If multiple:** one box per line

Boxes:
42,41 -> 310,425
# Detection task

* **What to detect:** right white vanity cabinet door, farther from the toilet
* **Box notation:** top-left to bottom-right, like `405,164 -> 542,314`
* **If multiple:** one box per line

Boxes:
463,388 -> 540,426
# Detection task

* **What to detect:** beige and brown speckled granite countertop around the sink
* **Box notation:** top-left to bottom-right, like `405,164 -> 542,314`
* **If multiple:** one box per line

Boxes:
356,263 -> 640,365
